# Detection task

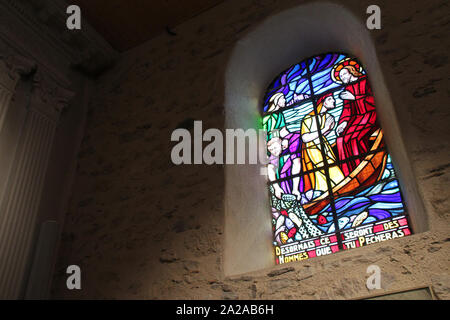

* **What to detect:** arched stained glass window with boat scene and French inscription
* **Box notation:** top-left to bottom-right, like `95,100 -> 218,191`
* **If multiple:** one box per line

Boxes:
263,53 -> 411,264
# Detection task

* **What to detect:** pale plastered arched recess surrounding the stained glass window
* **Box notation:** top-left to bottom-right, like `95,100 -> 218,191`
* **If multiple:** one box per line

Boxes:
223,3 -> 427,276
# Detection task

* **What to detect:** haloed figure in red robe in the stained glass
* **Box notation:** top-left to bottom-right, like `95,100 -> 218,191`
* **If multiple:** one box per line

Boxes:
332,59 -> 378,177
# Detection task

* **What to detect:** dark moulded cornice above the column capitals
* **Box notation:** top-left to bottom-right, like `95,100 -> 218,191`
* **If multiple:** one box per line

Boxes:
0,0 -> 118,75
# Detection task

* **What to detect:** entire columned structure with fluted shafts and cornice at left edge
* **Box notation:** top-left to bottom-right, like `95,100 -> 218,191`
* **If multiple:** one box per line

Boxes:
0,0 -> 114,299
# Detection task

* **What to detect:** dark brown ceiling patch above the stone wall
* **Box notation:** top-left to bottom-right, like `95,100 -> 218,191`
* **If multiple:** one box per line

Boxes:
72,0 -> 224,52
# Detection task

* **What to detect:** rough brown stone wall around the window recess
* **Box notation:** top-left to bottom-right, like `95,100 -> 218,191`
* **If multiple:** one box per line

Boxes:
53,0 -> 450,299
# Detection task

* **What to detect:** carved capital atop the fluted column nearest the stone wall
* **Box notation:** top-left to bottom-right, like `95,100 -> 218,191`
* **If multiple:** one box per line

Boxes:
30,70 -> 75,122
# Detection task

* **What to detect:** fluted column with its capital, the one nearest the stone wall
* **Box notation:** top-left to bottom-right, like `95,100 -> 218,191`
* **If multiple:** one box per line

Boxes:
0,72 -> 72,299
